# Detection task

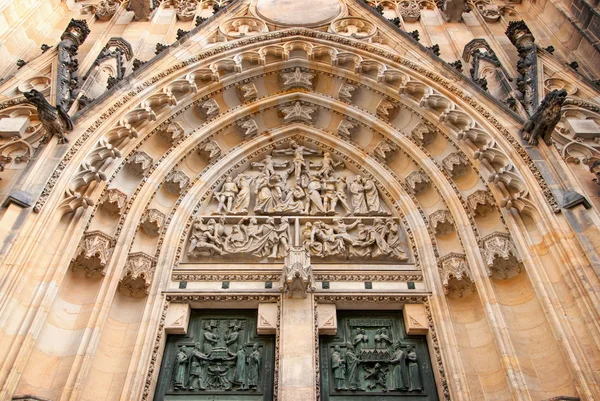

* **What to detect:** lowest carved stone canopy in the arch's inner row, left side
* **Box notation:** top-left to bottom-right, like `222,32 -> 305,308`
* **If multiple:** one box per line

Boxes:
119,252 -> 156,298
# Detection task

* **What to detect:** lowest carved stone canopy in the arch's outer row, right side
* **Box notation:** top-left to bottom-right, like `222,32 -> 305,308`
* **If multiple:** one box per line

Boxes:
481,232 -> 522,279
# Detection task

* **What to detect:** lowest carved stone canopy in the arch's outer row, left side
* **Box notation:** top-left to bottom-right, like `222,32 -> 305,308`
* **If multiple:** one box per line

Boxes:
71,231 -> 114,277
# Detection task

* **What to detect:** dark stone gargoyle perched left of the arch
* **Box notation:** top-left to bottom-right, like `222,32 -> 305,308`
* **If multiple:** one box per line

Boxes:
23,89 -> 73,144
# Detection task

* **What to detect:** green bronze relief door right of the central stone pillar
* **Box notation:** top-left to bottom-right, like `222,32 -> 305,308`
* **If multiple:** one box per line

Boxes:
319,311 -> 438,401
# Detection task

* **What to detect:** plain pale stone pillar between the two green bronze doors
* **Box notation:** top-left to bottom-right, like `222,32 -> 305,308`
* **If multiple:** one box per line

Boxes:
279,294 -> 317,401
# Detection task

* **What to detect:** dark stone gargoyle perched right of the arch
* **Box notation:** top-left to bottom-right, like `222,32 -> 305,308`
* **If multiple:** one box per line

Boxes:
520,89 -> 567,146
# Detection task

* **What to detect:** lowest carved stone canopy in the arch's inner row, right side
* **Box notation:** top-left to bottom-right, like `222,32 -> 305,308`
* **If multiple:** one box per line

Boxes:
439,253 -> 475,298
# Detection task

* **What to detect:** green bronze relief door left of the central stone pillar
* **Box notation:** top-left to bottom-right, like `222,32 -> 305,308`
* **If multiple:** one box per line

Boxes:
154,310 -> 275,401
